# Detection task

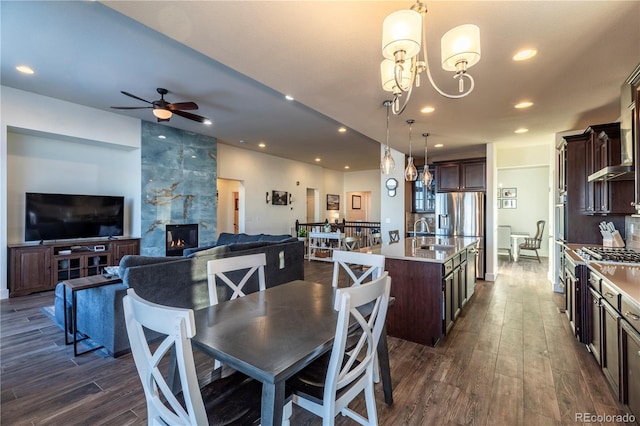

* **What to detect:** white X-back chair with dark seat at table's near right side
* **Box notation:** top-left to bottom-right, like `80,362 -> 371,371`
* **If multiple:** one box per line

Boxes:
287,272 -> 391,425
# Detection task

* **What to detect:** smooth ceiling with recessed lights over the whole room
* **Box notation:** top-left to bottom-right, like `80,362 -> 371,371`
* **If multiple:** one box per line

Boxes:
0,0 -> 640,171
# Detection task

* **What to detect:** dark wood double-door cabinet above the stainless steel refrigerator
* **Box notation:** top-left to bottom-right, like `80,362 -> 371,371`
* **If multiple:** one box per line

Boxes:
436,158 -> 487,192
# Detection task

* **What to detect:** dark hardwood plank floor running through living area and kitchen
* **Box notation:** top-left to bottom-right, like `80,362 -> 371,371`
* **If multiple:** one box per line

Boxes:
0,260 -> 636,425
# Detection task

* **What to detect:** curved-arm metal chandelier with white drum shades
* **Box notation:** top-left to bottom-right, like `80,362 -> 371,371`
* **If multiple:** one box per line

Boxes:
380,0 -> 480,115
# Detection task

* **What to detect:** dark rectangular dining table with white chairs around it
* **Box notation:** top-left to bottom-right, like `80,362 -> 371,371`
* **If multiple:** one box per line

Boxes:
191,280 -> 393,425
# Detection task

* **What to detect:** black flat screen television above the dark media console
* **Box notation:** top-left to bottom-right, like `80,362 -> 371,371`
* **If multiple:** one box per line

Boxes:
24,192 -> 124,241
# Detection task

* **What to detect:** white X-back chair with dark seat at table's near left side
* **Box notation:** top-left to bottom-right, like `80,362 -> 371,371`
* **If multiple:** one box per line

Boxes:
123,289 -> 292,425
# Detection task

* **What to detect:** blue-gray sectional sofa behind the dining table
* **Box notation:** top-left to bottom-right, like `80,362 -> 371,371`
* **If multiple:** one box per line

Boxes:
55,233 -> 304,357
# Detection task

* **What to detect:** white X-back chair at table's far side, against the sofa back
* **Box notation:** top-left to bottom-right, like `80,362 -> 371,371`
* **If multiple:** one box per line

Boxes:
207,253 -> 267,305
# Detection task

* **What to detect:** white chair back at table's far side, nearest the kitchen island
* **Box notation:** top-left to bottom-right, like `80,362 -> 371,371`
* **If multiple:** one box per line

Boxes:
331,250 -> 384,288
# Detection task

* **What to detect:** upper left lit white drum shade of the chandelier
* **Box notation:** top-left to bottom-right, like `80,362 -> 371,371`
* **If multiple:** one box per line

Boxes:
382,10 -> 422,60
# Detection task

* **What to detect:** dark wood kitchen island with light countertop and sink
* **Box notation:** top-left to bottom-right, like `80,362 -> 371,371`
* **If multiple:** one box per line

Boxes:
371,237 -> 477,346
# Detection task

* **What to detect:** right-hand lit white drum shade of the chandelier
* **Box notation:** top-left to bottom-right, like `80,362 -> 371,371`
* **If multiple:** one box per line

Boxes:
440,24 -> 480,71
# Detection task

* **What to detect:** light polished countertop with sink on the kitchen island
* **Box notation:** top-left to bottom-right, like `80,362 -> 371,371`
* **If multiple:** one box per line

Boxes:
370,236 -> 478,263
